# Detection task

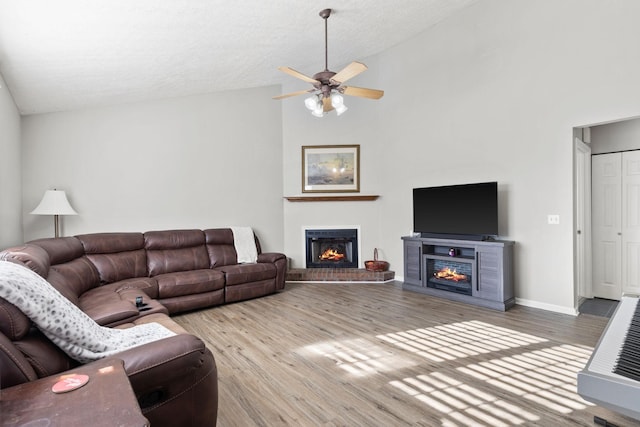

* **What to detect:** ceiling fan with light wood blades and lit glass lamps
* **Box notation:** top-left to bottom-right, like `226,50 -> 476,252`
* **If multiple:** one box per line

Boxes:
273,9 -> 384,117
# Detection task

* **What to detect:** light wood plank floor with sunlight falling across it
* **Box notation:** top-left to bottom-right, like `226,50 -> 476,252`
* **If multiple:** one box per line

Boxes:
174,282 -> 640,427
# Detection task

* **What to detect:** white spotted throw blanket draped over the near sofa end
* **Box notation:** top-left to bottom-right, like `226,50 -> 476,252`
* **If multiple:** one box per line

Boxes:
0,261 -> 175,363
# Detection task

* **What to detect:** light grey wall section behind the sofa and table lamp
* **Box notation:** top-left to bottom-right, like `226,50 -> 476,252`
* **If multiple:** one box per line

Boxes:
23,87 -> 283,251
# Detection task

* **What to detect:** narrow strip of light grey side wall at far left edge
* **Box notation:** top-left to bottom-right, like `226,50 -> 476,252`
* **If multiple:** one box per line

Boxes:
0,75 -> 22,248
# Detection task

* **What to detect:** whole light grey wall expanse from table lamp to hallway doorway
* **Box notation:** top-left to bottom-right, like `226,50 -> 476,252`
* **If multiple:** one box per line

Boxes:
16,0 -> 640,313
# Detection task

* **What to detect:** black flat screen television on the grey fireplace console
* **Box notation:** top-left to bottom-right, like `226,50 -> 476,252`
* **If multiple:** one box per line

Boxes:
413,182 -> 498,240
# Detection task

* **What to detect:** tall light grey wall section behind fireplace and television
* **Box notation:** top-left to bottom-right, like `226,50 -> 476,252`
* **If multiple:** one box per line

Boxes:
283,0 -> 640,313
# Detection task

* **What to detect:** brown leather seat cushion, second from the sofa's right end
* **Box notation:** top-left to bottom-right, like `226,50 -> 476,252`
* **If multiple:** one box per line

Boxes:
155,269 -> 224,299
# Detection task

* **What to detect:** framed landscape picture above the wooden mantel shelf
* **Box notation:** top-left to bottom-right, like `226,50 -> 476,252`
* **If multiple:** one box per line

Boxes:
302,145 -> 360,193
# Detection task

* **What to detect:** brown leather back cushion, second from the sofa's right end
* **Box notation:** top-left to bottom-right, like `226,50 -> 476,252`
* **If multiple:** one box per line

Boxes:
144,230 -> 209,276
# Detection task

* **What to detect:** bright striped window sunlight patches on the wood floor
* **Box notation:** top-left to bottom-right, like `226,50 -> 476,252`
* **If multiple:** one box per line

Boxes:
301,321 -> 593,427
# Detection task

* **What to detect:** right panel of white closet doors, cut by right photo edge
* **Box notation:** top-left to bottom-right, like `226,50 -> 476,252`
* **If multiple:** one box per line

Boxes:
622,151 -> 640,293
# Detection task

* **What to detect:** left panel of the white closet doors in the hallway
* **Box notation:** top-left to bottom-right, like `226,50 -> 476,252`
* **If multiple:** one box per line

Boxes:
591,153 -> 622,300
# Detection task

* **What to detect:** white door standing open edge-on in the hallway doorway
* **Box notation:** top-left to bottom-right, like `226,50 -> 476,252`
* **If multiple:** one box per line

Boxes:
574,138 -> 593,300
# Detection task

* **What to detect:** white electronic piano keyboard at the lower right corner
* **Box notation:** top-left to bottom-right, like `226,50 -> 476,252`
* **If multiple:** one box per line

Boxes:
578,295 -> 640,420
